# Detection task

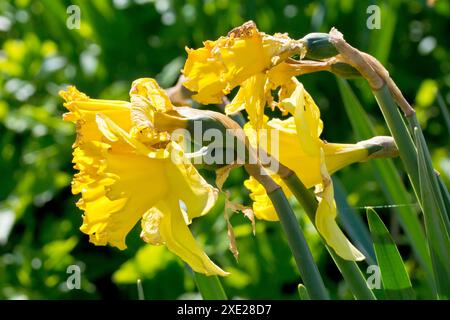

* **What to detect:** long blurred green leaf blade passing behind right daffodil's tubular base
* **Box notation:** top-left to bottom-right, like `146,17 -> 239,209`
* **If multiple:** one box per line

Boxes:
337,78 -> 434,287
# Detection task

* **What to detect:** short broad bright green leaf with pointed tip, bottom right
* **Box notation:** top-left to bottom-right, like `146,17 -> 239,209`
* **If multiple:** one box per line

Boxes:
367,209 -> 414,300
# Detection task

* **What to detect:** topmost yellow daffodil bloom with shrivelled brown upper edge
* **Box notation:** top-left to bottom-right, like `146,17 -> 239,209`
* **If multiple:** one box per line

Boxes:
183,21 -> 304,126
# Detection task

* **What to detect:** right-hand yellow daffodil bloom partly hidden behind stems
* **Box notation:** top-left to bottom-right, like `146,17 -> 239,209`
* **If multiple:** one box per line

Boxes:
245,78 -> 369,260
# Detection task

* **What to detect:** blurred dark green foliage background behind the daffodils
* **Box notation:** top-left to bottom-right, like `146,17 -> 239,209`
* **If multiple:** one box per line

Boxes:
0,0 -> 450,299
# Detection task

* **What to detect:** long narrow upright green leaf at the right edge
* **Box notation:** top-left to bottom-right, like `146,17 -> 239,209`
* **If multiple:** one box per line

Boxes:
414,127 -> 450,299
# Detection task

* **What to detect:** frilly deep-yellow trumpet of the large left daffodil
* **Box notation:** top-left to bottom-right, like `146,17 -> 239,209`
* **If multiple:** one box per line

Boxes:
74,142 -> 169,249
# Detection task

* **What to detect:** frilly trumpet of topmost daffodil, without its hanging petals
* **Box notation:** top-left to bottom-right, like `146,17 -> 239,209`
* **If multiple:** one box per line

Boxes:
183,21 -> 303,104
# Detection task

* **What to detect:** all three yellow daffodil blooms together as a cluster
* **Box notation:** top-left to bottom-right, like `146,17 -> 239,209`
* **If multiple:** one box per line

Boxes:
60,22 -> 382,275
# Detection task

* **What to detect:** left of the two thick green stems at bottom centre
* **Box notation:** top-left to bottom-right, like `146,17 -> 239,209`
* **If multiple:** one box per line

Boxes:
267,187 -> 329,300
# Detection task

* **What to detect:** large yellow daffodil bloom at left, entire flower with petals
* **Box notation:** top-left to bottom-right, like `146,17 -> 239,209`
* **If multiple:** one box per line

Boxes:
60,79 -> 227,276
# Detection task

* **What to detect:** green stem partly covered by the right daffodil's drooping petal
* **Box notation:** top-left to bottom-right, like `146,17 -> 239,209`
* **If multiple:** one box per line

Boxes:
282,171 -> 376,300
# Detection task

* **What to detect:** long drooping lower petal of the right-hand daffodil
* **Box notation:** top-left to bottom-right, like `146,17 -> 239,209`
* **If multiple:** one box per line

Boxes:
315,150 -> 365,261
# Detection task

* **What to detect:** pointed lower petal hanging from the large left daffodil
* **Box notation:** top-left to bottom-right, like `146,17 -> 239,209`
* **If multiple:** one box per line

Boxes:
141,198 -> 228,276
